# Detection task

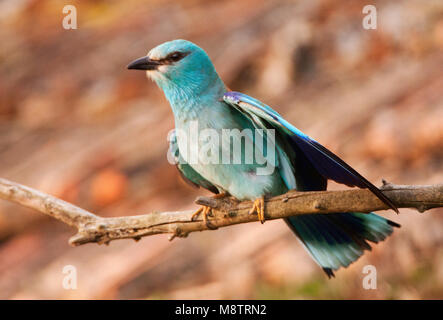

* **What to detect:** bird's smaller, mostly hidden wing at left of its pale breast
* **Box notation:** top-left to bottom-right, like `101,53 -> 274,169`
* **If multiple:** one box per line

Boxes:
168,130 -> 219,193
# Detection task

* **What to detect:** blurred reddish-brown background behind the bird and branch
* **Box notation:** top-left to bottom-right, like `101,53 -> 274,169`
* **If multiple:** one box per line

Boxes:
0,0 -> 443,299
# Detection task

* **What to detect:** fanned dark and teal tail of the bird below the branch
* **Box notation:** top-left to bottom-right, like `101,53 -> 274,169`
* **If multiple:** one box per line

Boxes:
285,213 -> 400,278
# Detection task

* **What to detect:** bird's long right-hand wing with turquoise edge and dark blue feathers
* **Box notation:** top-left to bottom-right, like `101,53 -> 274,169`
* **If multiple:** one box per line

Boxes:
223,91 -> 398,212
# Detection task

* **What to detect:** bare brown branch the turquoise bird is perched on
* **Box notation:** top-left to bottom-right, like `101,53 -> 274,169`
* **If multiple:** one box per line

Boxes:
0,178 -> 443,246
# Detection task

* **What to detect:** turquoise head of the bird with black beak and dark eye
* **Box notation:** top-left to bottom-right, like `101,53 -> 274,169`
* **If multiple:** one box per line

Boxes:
128,40 -> 224,100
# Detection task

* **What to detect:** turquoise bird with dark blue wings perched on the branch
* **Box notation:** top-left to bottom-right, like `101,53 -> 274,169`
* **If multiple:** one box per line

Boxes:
128,40 -> 399,278
